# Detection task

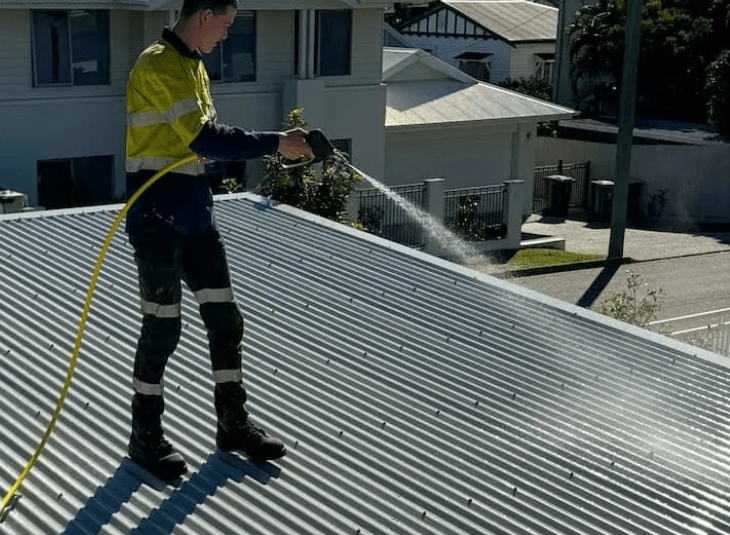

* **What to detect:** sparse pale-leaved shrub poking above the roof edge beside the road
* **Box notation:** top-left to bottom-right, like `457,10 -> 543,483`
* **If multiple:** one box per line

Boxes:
596,270 -> 664,328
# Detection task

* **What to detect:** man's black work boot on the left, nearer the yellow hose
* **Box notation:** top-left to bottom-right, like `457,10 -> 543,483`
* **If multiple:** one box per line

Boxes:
127,394 -> 188,482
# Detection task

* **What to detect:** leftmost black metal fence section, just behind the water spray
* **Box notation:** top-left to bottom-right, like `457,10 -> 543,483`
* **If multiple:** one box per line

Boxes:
357,184 -> 426,247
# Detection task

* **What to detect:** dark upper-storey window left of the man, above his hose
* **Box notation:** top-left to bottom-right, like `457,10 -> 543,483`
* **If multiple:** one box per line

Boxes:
33,9 -> 109,86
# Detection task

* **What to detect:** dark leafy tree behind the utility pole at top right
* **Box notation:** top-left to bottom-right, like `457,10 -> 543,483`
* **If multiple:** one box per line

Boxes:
570,0 -> 730,121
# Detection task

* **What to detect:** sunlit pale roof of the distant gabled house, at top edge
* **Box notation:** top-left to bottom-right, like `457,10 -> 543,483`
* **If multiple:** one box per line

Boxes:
442,0 -> 558,42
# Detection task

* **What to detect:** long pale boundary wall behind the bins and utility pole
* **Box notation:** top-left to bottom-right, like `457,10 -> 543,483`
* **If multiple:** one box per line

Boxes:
536,137 -> 730,225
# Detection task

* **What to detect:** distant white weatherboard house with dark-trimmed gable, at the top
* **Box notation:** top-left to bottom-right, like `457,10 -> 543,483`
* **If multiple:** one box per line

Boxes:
396,0 -> 558,83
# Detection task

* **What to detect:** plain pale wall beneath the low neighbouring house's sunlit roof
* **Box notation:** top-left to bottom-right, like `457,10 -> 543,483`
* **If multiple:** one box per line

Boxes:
385,123 -> 536,215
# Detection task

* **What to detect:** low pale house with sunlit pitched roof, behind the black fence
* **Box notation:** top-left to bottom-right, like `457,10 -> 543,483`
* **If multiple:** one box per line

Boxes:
383,47 -> 575,216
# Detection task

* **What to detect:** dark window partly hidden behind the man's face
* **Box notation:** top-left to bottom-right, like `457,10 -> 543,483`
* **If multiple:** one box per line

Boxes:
203,11 -> 256,82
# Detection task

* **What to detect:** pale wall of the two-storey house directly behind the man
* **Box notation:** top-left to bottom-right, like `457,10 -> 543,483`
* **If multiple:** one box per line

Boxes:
0,6 -> 385,204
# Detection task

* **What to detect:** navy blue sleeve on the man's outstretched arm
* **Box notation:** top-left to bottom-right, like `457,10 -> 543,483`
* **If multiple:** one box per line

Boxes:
188,121 -> 279,161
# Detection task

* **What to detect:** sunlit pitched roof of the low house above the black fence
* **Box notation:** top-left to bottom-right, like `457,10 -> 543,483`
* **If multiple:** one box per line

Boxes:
383,48 -> 575,128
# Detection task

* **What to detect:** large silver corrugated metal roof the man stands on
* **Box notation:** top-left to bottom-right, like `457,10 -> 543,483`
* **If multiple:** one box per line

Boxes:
0,195 -> 730,535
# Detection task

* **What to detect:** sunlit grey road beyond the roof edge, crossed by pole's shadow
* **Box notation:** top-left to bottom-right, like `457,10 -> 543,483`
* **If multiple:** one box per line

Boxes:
512,252 -> 730,330
